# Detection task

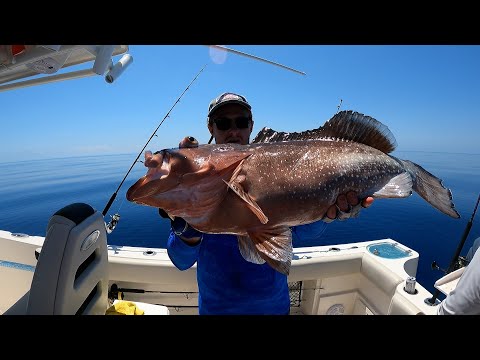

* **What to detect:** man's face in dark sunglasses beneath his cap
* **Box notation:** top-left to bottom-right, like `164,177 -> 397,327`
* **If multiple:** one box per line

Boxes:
208,104 -> 253,145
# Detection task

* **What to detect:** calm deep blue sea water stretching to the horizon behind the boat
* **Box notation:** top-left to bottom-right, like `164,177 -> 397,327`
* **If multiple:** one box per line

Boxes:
0,152 -> 480,292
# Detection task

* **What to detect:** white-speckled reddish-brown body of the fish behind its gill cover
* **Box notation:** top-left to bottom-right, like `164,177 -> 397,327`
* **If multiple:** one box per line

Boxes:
227,140 -> 411,226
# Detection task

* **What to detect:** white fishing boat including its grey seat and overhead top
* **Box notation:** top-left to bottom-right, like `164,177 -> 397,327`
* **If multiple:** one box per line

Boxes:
0,45 -> 464,315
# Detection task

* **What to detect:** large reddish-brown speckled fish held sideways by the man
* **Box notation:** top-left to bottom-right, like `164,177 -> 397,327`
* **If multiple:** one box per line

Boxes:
127,111 -> 460,274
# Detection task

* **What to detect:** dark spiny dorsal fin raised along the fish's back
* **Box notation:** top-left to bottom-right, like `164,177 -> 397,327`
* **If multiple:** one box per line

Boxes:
252,110 -> 397,154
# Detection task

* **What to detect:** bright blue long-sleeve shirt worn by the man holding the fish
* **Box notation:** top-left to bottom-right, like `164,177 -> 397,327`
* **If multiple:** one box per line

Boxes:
167,221 -> 327,315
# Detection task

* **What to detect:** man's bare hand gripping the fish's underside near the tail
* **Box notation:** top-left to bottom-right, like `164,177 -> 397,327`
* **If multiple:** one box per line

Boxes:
322,191 -> 373,223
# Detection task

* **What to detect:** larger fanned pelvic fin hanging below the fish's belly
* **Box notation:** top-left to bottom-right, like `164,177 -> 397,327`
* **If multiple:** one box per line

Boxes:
248,227 -> 293,275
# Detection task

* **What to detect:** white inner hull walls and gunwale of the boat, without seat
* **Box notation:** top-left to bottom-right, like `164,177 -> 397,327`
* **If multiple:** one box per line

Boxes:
0,231 -> 436,315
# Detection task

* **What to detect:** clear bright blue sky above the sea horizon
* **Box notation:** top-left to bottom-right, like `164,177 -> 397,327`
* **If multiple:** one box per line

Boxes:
0,45 -> 480,162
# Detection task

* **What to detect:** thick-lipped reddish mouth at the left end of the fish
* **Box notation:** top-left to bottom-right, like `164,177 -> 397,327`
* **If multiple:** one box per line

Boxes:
126,150 -> 171,204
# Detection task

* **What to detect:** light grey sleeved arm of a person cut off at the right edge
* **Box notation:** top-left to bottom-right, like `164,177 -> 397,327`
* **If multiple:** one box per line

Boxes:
437,239 -> 480,315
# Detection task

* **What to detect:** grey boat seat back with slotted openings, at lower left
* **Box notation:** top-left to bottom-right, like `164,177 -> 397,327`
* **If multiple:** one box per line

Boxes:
4,203 -> 166,315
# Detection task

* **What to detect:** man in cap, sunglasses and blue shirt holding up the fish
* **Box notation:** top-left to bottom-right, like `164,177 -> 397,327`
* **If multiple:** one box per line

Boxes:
156,93 -> 373,315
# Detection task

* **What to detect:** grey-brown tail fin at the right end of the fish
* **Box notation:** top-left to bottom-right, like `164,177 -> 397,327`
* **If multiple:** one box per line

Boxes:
397,159 -> 460,218
